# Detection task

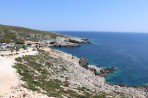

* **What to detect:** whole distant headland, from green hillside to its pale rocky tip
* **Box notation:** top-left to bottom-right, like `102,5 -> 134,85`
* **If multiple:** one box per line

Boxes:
0,25 -> 90,47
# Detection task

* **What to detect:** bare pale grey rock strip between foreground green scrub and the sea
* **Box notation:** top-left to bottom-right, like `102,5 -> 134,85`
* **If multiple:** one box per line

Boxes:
40,50 -> 148,98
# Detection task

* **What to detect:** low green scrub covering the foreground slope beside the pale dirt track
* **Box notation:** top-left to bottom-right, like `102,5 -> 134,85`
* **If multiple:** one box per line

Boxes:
14,50 -> 112,98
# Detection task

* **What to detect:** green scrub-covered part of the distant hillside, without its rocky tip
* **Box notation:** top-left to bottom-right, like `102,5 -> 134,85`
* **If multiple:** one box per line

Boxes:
0,25 -> 63,42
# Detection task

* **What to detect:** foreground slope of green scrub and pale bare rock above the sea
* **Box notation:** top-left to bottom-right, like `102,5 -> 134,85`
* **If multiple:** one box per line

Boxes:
15,48 -> 148,98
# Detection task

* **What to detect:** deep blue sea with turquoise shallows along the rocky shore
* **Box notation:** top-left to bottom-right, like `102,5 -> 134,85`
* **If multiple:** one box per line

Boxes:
53,32 -> 148,86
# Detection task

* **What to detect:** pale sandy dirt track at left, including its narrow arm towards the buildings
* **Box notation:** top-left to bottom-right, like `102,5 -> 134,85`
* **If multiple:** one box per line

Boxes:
0,49 -> 37,95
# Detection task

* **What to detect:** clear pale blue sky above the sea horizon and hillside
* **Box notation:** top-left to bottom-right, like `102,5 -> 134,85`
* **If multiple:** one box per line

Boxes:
0,0 -> 148,32
